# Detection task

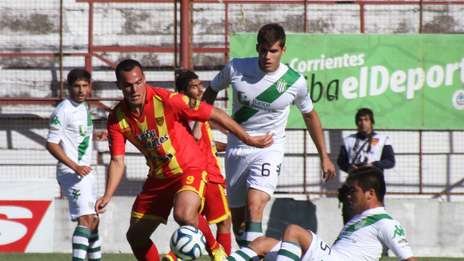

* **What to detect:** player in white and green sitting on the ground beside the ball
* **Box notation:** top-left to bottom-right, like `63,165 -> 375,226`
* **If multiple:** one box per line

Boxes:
228,167 -> 416,261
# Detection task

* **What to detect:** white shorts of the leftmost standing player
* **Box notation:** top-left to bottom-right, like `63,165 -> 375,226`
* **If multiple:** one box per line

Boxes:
56,171 -> 97,221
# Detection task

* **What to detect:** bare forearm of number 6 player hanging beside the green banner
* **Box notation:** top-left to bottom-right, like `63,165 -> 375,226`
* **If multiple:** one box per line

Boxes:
303,110 -> 335,180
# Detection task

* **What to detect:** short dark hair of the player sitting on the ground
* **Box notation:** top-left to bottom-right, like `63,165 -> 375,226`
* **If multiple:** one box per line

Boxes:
346,167 -> 387,202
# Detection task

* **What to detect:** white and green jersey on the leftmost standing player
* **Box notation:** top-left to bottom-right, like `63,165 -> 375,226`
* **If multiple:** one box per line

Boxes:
47,99 -> 93,173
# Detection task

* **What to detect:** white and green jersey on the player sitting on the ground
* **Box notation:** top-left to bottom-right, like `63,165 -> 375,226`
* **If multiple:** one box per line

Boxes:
332,207 -> 413,261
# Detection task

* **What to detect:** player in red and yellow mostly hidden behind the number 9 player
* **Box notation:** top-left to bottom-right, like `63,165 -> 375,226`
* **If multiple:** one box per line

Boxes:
176,70 -> 231,260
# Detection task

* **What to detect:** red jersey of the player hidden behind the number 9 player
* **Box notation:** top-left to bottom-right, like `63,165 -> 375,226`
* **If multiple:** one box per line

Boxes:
198,122 -> 225,184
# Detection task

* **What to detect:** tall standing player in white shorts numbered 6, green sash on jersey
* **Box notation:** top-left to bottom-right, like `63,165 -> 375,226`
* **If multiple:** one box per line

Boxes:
203,24 -> 335,245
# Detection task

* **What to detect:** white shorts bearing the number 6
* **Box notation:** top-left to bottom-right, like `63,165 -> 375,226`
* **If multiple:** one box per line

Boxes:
225,143 -> 284,208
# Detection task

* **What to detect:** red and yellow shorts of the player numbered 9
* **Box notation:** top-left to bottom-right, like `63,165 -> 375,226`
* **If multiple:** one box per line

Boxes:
131,170 -> 207,223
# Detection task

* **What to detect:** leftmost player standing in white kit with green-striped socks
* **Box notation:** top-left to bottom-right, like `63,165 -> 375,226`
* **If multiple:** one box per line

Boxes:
47,69 -> 101,261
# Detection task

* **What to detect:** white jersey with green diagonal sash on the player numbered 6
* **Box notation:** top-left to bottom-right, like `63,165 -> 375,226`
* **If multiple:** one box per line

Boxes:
211,57 -> 313,146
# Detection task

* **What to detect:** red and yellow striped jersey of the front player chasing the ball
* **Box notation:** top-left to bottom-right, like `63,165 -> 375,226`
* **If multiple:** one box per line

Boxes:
107,85 -> 213,178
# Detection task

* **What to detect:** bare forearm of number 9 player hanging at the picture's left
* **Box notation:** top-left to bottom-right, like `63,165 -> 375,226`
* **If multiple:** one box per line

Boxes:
95,155 -> 125,213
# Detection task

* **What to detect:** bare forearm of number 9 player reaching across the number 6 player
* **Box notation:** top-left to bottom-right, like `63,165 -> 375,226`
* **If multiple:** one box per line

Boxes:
210,108 -> 273,148
